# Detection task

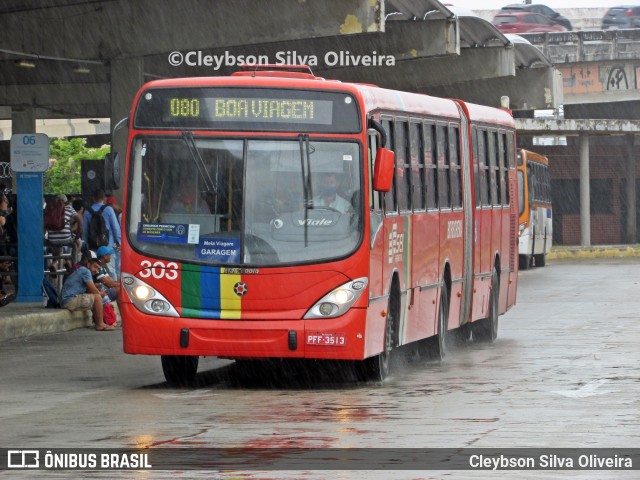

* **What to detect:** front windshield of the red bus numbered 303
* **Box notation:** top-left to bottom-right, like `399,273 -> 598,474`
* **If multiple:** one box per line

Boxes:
127,133 -> 363,266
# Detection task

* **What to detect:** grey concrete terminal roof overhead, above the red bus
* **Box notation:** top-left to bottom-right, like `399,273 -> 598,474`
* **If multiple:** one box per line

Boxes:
0,0 -> 561,118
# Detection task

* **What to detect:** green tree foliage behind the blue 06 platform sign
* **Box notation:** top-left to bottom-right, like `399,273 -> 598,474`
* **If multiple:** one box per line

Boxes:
44,138 -> 111,195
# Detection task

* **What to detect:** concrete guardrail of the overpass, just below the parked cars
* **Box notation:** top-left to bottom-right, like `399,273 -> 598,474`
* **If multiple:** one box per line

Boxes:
520,29 -> 640,64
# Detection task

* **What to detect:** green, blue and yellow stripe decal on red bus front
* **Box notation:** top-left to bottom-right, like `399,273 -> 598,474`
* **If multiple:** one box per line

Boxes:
180,265 -> 246,320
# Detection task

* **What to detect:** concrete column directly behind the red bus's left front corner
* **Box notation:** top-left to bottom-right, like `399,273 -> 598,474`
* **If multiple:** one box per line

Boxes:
111,57 -> 144,197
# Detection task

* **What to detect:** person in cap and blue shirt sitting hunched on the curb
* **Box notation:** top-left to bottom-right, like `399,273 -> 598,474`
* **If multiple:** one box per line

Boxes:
59,259 -> 115,332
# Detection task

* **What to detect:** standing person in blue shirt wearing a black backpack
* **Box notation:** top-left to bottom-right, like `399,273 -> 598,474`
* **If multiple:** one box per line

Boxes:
83,190 -> 121,272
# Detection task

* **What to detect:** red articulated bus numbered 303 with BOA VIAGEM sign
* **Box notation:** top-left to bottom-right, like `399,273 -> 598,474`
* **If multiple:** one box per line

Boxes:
119,66 -> 518,383
